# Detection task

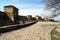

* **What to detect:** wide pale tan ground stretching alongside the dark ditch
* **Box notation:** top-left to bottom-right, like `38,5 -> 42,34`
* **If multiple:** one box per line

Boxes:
0,22 -> 59,40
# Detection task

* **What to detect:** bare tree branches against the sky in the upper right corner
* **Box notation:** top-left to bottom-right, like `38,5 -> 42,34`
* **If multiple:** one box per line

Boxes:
43,0 -> 60,17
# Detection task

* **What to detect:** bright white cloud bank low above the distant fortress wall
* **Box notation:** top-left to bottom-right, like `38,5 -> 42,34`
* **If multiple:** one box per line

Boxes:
19,9 -> 48,16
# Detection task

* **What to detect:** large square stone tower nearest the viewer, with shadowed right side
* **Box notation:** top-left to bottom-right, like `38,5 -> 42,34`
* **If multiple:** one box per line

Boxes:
4,5 -> 19,24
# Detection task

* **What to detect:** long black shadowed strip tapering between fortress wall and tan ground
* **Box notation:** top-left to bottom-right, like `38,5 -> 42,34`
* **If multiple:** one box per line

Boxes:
0,22 -> 36,34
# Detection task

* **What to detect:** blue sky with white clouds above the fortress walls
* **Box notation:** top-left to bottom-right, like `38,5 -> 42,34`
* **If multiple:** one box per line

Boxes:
0,0 -> 60,20
